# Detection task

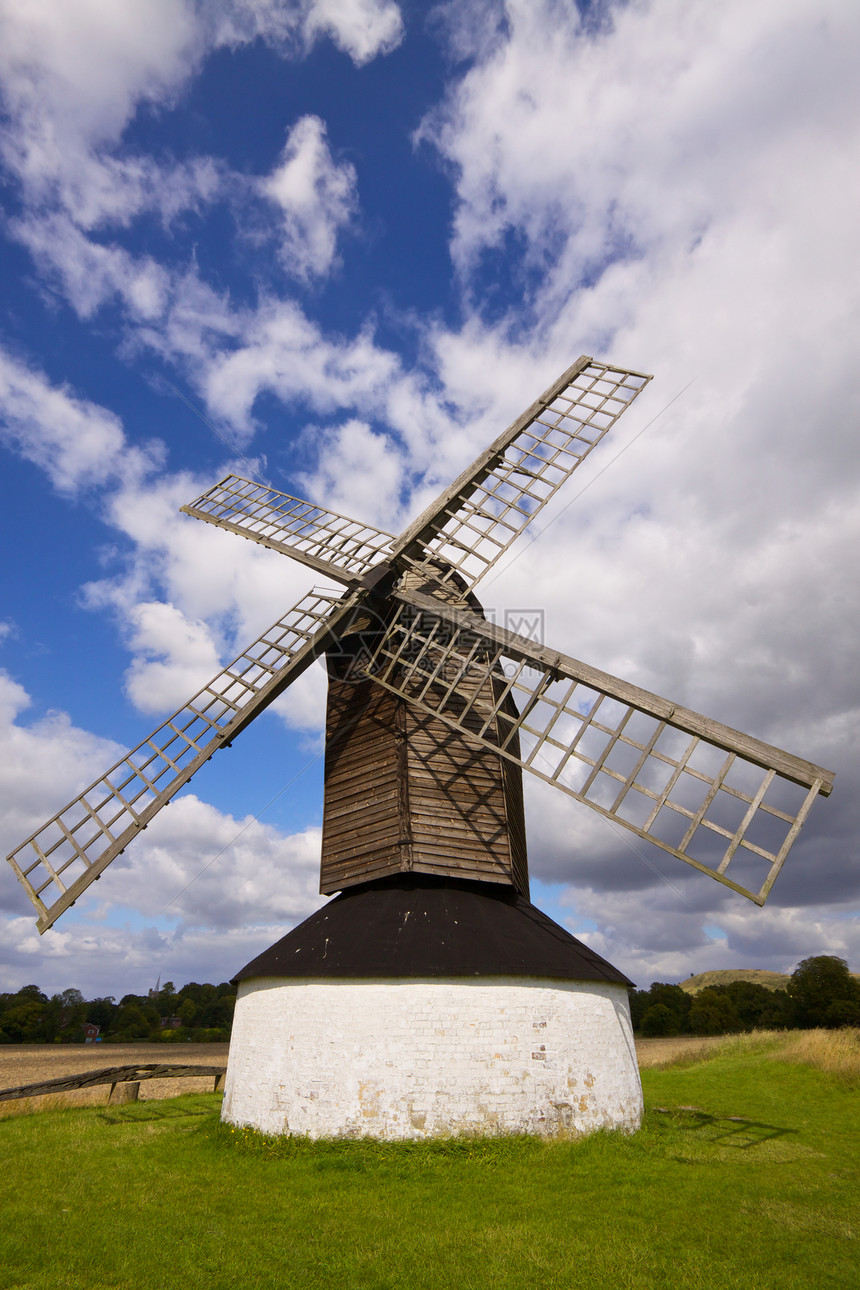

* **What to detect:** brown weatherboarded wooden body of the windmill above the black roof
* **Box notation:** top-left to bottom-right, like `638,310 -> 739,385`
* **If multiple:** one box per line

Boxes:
320,583 -> 529,897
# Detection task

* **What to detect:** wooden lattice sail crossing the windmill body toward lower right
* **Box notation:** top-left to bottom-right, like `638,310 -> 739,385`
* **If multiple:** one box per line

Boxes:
367,591 -> 833,904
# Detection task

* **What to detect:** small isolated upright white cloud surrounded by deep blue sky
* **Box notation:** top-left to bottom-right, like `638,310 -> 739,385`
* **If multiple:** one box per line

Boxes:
260,116 -> 356,279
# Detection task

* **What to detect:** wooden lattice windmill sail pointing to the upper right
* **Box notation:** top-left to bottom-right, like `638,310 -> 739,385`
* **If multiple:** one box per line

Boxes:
393,357 -> 651,587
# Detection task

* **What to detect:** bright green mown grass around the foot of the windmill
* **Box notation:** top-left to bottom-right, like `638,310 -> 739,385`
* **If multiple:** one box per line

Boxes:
0,1032 -> 860,1290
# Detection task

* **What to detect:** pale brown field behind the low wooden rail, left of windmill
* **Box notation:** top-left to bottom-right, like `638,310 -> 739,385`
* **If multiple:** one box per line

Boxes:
0,1044 -> 230,1117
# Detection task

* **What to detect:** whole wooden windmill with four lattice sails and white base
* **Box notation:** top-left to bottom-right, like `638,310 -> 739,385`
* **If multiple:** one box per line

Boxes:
3,357 -> 833,1138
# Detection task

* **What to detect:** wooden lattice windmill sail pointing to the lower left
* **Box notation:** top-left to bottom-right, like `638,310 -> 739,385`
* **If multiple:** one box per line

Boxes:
8,591 -> 355,931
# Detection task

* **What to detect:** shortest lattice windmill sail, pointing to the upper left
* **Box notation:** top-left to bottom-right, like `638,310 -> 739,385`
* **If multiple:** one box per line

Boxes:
181,475 -> 395,586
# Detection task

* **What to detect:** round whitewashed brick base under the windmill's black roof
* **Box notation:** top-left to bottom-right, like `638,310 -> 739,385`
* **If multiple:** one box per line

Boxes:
222,977 -> 642,1139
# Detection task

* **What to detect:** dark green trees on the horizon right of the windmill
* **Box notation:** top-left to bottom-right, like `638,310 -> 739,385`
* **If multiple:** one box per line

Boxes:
630,955 -> 860,1037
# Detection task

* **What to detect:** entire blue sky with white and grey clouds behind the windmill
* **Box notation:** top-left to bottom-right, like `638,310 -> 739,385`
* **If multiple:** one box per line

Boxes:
0,0 -> 860,996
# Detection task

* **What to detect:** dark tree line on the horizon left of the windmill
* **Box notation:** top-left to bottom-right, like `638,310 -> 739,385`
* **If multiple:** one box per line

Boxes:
0,980 -> 236,1044
